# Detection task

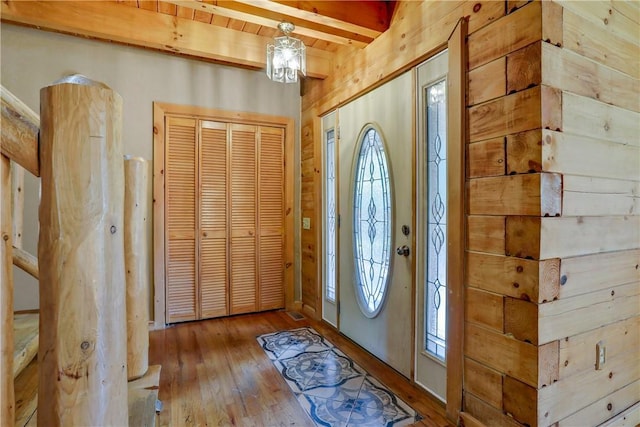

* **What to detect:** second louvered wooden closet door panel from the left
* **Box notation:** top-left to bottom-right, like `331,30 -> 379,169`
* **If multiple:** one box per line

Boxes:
200,121 -> 229,319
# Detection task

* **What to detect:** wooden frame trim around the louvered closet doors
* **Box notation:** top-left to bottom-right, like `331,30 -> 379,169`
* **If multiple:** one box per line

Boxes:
152,102 -> 296,329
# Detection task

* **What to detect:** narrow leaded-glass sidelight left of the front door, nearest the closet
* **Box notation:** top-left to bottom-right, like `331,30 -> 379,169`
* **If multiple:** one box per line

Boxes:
324,129 -> 338,302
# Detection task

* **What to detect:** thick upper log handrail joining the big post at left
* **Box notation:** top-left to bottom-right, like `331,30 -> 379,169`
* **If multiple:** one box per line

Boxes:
0,85 -> 40,176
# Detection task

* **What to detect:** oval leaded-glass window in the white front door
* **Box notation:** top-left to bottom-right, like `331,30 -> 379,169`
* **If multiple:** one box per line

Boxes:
353,125 -> 391,317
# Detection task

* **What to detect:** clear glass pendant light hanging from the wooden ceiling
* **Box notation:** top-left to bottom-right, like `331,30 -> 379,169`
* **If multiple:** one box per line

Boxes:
267,22 -> 307,83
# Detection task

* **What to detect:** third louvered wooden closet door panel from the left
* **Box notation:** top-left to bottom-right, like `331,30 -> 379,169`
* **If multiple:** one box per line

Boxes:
229,124 -> 257,314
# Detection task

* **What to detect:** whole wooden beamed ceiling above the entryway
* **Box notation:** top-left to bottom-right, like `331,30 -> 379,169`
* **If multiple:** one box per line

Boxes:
2,0 -> 395,78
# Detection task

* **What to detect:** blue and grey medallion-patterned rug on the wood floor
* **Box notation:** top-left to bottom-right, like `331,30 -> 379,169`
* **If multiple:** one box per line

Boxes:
257,328 -> 421,427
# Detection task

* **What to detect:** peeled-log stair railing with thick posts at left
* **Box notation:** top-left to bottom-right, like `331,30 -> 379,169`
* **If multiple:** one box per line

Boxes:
0,76 -> 152,425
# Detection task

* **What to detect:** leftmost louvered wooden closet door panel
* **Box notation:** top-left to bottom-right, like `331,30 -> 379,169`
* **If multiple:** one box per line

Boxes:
165,117 -> 198,323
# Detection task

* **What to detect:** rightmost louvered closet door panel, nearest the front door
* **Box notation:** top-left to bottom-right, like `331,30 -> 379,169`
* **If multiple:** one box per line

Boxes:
258,127 -> 284,310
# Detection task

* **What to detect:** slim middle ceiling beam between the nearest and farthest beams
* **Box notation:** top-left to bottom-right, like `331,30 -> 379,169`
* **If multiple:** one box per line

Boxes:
168,0 -> 373,48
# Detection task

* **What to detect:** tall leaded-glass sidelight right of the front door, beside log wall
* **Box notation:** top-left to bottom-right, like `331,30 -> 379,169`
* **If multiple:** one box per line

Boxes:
425,80 -> 447,361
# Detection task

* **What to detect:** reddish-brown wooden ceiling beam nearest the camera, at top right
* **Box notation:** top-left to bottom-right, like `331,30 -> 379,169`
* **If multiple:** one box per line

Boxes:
231,0 -> 391,38
